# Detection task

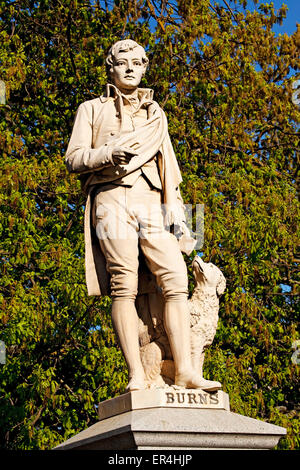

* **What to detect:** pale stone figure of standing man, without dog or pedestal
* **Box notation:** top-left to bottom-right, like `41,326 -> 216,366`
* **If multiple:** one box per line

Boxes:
66,39 -> 221,391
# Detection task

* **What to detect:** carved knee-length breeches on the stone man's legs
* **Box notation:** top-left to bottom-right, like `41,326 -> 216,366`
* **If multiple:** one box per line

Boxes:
94,176 -> 188,301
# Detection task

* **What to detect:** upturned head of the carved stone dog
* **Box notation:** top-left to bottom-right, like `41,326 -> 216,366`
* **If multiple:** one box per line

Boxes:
192,256 -> 226,297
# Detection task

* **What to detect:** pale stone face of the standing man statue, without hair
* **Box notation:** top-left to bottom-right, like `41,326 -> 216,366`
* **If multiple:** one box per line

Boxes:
111,47 -> 146,91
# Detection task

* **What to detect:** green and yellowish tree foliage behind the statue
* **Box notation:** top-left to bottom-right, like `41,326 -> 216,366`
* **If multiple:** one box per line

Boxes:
0,0 -> 300,449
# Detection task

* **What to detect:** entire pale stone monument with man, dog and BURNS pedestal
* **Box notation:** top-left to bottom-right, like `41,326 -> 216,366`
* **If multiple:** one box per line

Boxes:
57,39 -> 285,450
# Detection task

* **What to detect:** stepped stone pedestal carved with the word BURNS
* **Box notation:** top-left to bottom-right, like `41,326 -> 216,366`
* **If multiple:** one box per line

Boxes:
55,388 -> 286,450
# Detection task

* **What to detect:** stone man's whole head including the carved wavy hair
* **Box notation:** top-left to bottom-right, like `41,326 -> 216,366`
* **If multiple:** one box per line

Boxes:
106,39 -> 149,90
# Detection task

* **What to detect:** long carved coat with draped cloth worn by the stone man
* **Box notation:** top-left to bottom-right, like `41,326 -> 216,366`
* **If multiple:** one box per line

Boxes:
66,84 -> 196,295
